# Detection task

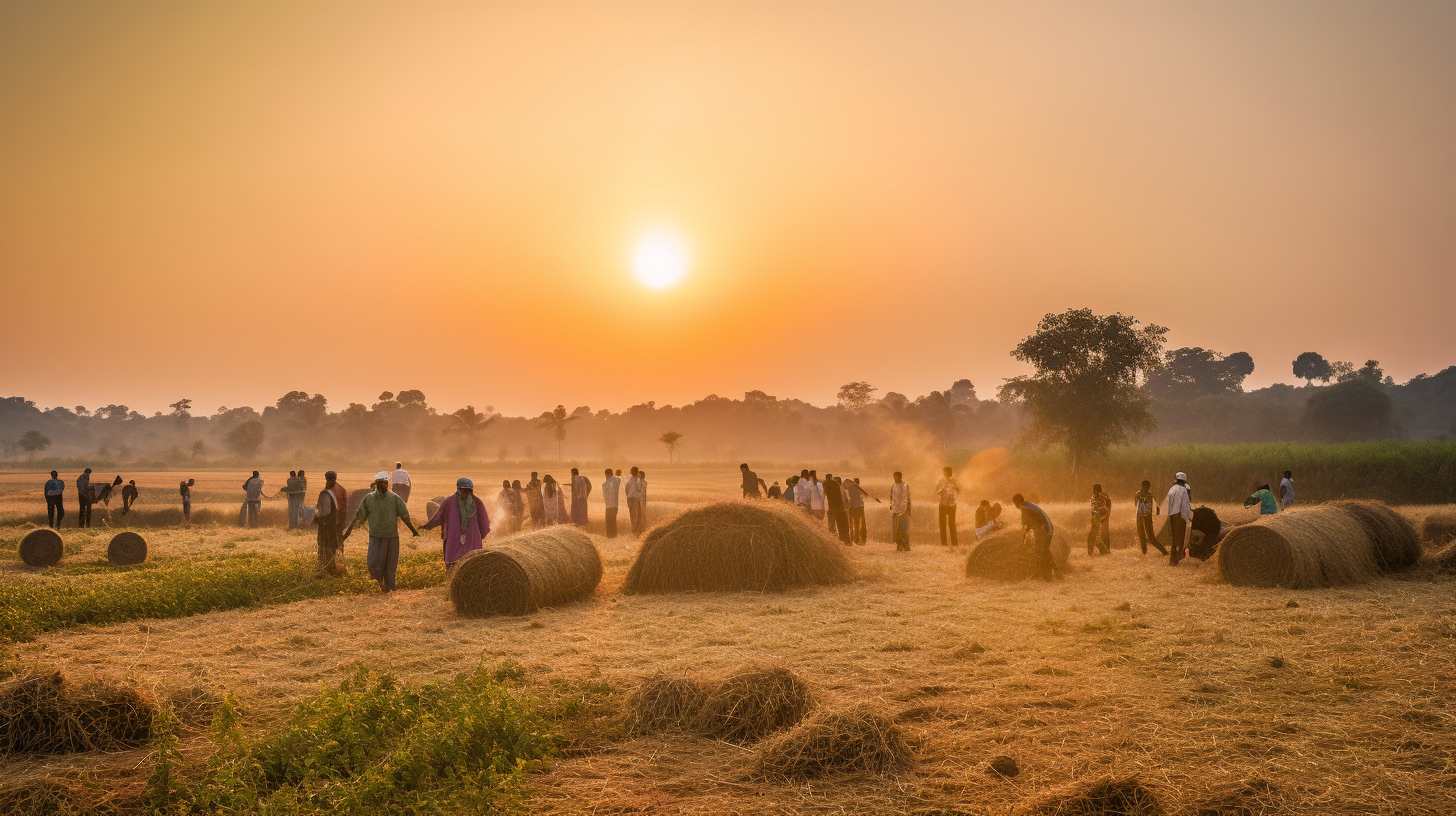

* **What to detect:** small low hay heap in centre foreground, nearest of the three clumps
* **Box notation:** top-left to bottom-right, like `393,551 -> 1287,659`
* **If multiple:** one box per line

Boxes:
756,707 -> 910,780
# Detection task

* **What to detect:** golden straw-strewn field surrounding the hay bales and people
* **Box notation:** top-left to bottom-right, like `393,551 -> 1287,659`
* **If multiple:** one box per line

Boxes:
0,466 -> 1456,816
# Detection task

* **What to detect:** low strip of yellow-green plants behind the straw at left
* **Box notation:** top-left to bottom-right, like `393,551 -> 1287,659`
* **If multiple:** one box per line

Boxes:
0,554 -> 446,641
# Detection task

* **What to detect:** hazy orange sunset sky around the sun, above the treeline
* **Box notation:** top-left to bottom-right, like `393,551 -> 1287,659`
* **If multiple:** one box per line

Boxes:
0,0 -> 1456,412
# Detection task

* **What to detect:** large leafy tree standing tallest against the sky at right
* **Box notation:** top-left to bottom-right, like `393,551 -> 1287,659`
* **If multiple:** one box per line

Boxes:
1000,309 -> 1168,475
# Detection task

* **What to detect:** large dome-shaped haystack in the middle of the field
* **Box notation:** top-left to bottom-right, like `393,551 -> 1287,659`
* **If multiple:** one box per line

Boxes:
622,501 -> 855,595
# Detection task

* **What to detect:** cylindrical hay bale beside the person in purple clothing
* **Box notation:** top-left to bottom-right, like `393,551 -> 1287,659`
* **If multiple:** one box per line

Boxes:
450,526 -> 601,616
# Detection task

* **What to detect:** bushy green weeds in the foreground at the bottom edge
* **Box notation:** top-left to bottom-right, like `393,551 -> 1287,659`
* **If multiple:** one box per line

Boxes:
147,666 -> 555,816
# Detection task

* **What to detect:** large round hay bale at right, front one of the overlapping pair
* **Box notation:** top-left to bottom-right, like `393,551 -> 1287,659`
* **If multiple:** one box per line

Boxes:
1219,506 -> 1380,589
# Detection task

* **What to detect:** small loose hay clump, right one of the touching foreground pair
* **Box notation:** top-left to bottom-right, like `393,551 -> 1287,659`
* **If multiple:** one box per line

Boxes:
695,667 -> 814,745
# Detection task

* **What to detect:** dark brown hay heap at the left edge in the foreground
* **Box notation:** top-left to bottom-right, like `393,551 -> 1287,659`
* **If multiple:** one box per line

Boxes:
0,673 -> 157,753
